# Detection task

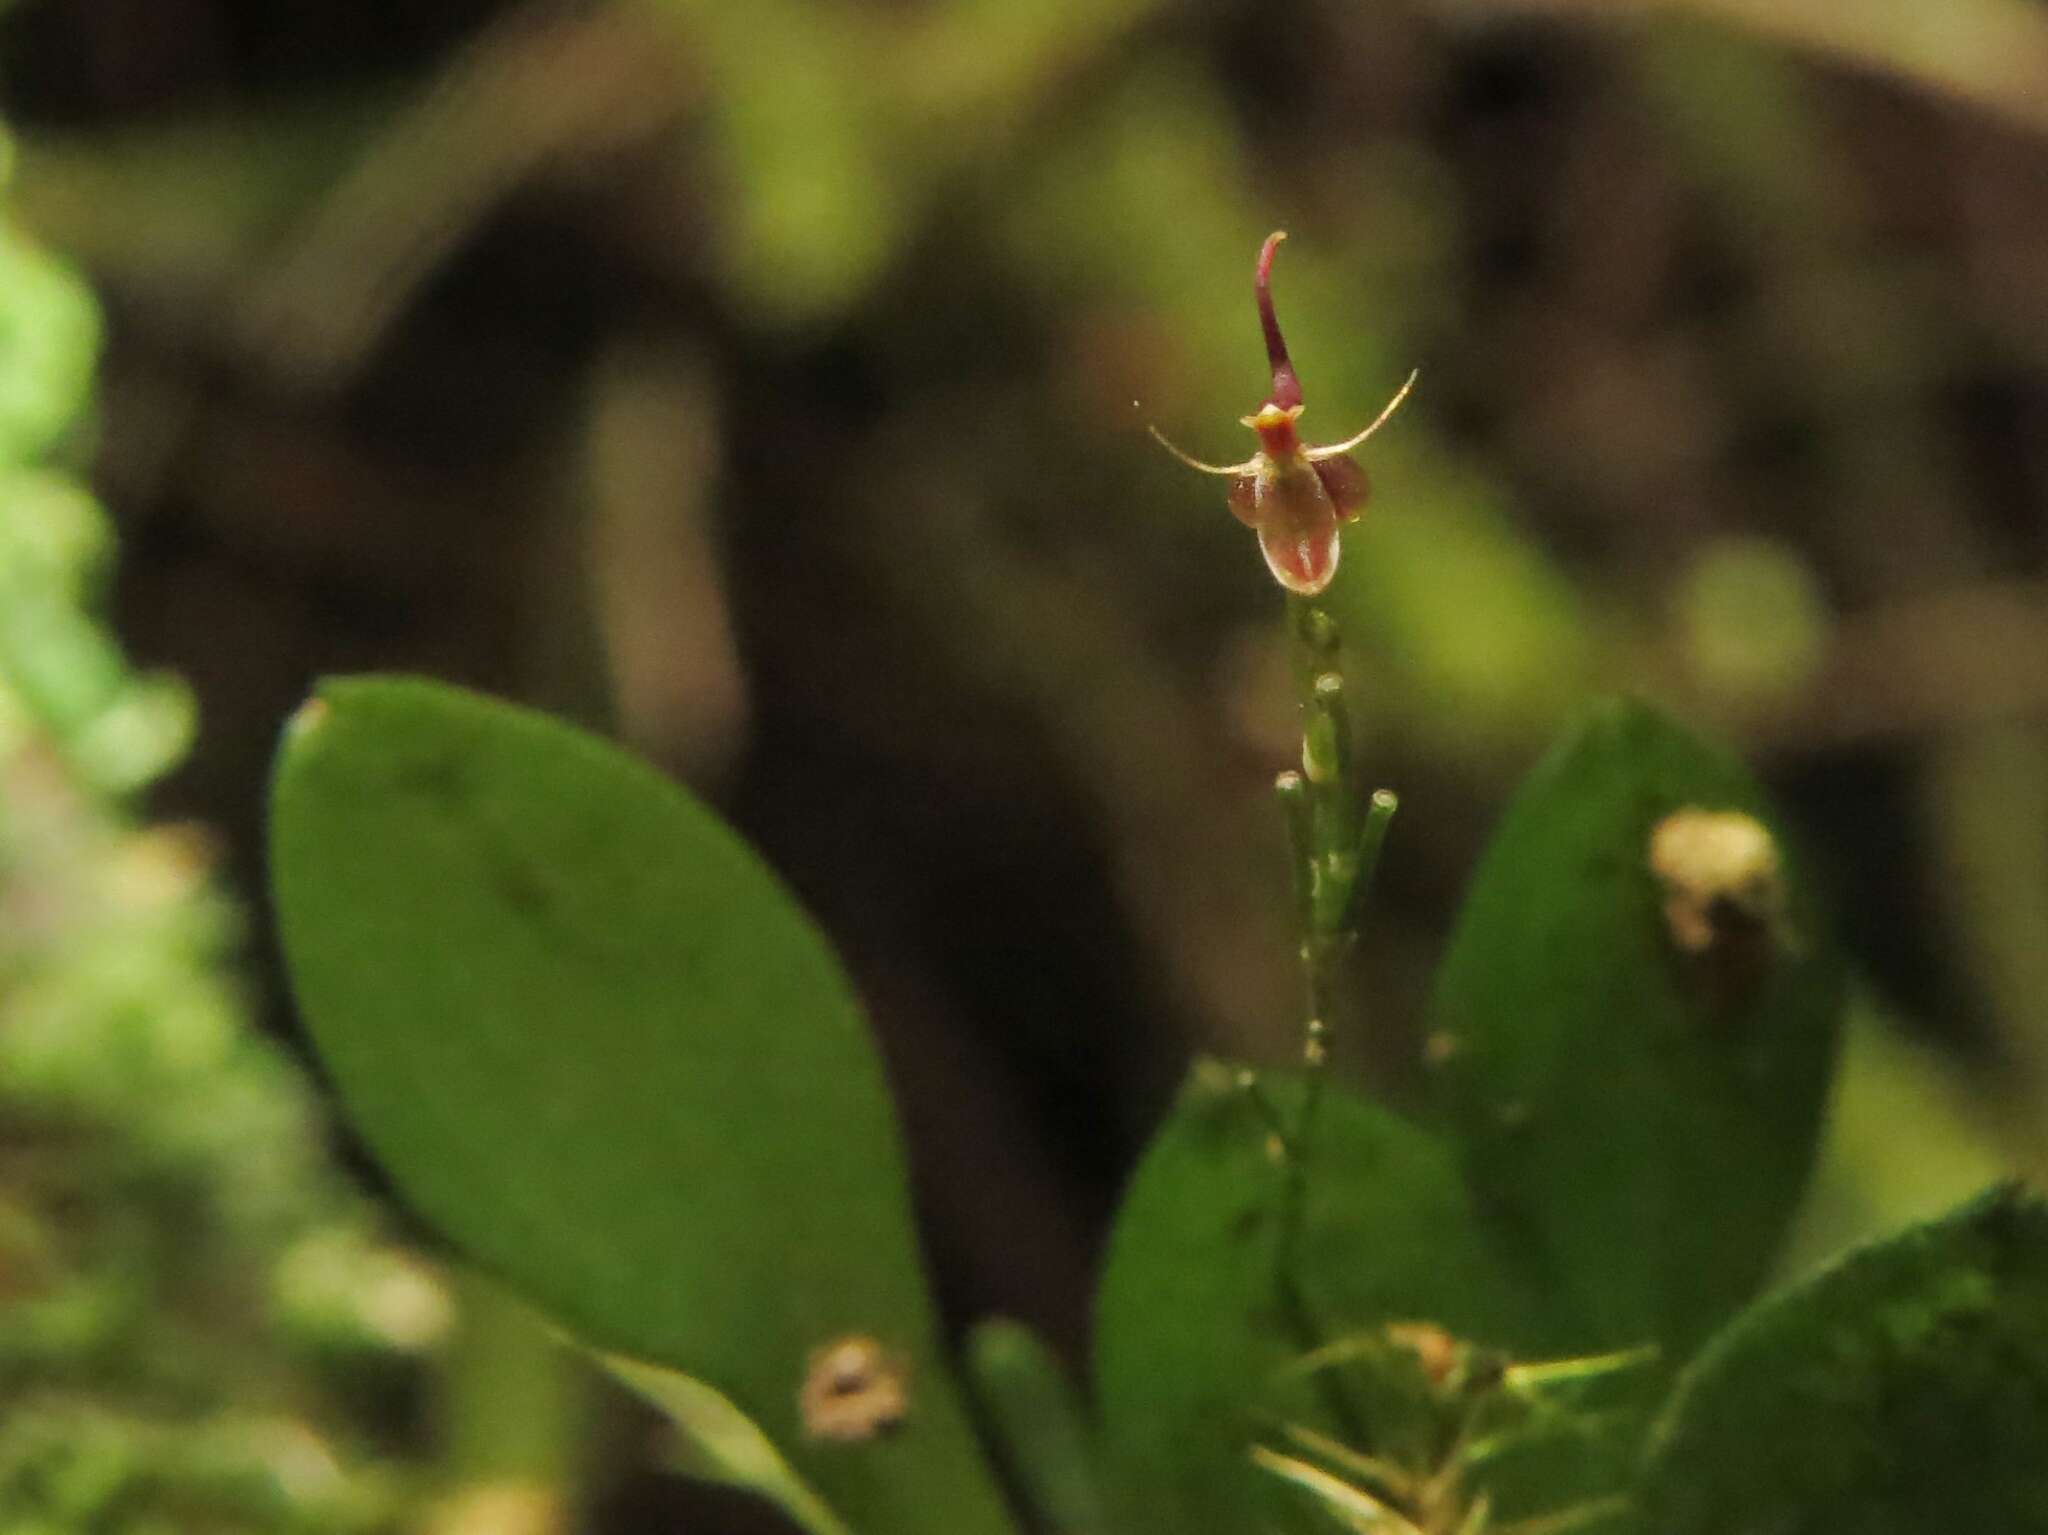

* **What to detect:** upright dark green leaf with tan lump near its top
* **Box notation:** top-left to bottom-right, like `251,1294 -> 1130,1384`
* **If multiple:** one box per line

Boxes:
1430,702 -> 1841,1355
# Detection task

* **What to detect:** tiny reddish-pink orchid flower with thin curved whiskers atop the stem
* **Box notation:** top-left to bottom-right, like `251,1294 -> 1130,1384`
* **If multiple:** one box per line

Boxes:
1147,229 -> 1415,598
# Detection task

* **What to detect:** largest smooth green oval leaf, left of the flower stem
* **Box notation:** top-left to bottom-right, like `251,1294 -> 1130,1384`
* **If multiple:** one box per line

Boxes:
270,677 -> 1006,1535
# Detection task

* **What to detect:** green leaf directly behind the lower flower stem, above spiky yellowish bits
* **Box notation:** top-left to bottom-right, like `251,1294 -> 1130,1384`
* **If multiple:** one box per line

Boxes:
1096,1060 -> 1536,1535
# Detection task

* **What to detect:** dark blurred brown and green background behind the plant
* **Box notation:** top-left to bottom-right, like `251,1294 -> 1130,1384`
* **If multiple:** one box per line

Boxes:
0,0 -> 2048,1529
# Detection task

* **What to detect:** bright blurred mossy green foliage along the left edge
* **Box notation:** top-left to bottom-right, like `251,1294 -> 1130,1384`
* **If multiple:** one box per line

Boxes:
0,129 -> 449,1535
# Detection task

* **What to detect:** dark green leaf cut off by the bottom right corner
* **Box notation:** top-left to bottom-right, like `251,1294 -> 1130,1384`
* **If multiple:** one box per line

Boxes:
1640,1189 -> 2048,1535
